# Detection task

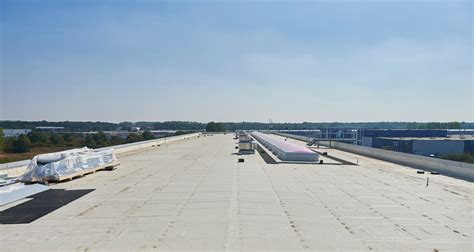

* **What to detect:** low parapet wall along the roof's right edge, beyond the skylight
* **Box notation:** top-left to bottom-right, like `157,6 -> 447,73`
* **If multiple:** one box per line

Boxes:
276,133 -> 474,182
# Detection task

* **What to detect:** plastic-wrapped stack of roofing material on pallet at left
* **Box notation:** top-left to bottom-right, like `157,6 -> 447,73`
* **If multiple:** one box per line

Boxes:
21,147 -> 119,182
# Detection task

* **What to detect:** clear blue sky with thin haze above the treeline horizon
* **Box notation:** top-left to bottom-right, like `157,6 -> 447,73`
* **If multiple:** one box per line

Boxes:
0,0 -> 474,122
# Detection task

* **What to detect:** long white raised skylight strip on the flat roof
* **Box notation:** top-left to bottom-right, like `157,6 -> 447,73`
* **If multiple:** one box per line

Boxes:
252,132 -> 319,162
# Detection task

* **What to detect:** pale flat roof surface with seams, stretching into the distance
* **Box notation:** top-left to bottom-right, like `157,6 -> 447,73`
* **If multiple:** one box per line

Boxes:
0,134 -> 474,251
